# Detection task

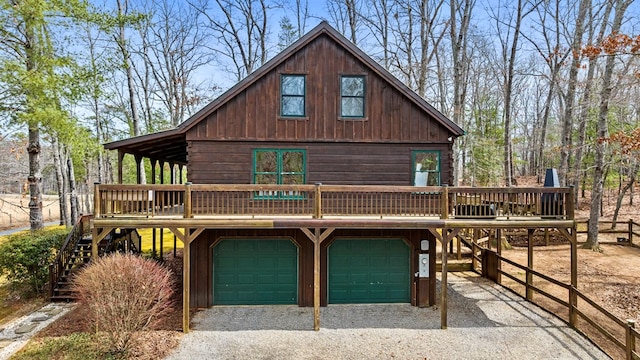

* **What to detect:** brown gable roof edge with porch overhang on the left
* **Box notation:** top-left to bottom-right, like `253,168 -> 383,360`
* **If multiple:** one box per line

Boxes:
104,21 -> 464,163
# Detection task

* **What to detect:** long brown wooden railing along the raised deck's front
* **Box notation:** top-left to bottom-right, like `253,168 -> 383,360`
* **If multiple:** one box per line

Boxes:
95,183 -> 574,219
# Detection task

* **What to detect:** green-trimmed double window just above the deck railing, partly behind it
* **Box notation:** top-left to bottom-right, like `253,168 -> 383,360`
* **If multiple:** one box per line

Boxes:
253,149 -> 307,199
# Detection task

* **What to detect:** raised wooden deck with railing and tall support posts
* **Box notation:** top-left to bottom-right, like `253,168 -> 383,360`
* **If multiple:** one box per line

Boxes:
92,183 -> 577,332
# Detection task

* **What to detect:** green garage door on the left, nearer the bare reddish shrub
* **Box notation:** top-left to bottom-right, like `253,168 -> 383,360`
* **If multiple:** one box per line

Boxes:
213,239 -> 298,305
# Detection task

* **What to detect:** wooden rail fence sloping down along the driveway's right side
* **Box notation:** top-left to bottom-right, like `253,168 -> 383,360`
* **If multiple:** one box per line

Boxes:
472,248 -> 640,360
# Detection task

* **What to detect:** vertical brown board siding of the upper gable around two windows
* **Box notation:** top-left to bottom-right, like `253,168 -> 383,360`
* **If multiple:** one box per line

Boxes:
187,36 -> 451,143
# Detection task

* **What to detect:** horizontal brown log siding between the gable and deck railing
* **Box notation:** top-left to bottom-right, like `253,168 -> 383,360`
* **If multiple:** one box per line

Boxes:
188,141 -> 453,185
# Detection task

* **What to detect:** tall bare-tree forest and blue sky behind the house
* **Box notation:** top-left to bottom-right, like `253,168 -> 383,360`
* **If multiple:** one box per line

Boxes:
0,0 -> 640,248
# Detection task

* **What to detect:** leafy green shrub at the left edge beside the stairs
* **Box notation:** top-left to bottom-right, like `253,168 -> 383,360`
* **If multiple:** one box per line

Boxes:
0,229 -> 69,297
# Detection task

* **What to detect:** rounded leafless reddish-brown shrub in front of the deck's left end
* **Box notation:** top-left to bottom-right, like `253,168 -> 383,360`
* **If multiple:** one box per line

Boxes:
74,253 -> 173,355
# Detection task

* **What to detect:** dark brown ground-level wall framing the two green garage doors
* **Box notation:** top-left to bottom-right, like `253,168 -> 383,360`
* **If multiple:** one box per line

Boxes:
189,229 -> 436,308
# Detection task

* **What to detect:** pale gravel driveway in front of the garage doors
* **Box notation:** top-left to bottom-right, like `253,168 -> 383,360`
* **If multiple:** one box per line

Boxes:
168,274 -> 609,360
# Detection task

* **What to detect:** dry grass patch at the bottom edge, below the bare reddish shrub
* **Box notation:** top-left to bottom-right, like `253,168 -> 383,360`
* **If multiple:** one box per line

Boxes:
11,333 -> 118,360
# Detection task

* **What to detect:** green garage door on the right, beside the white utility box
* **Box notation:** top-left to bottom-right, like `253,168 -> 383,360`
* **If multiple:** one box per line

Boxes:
328,239 -> 411,304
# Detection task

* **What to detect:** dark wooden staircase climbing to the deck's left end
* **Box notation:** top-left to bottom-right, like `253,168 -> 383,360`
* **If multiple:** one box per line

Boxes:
49,215 -> 141,301
